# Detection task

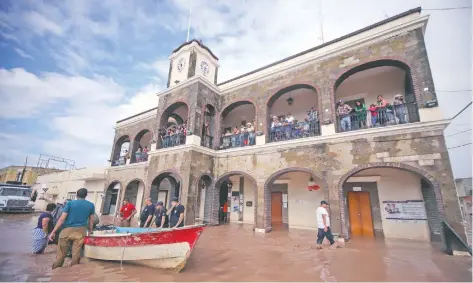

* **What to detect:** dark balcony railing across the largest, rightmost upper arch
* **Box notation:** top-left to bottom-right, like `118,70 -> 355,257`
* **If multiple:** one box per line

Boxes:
337,102 -> 419,132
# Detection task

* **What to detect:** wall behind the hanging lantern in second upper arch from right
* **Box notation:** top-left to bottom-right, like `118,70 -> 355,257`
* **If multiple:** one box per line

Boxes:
269,89 -> 320,122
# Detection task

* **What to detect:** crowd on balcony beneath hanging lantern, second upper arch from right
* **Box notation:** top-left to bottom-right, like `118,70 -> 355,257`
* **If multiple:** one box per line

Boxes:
270,106 -> 320,142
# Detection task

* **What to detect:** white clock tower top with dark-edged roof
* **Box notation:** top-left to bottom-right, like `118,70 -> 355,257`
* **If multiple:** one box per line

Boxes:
167,39 -> 219,87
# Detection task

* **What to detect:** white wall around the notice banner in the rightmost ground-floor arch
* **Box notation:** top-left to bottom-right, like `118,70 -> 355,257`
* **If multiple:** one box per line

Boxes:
354,168 -> 430,241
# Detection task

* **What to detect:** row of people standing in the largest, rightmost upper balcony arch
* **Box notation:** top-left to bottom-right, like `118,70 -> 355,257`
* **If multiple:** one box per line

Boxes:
337,94 -> 409,132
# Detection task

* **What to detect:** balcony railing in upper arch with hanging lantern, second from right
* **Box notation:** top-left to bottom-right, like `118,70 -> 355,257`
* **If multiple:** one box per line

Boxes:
269,121 -> 320,142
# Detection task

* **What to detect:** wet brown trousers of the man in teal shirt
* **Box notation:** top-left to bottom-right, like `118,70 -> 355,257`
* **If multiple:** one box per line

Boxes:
53,227 -> 86,269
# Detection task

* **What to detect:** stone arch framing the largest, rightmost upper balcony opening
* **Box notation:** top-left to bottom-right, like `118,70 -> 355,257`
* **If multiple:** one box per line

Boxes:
330,56 -> 421,126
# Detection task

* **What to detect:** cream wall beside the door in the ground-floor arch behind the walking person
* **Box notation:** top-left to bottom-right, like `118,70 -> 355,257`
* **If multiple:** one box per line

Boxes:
279,172 -> 324,229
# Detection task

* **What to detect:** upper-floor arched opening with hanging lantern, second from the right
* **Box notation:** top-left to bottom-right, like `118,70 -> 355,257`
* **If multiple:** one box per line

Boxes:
267,84 -> 320,142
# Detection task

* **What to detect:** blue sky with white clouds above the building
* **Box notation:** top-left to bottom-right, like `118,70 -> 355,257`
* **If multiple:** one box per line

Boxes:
0,0 -> 472,177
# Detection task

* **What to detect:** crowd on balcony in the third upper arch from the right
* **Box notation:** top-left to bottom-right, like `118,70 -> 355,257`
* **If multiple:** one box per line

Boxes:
220,121 -> 256,149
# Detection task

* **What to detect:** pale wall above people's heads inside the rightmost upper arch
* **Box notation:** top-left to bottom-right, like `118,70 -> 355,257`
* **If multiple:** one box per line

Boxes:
335,66 -> 405,107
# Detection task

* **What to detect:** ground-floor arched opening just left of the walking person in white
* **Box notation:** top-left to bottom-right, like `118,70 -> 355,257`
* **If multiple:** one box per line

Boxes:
264,168 -> 326,231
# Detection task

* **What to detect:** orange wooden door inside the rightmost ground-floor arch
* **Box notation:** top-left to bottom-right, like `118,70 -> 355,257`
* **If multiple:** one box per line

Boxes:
348,192 -> 374,237
